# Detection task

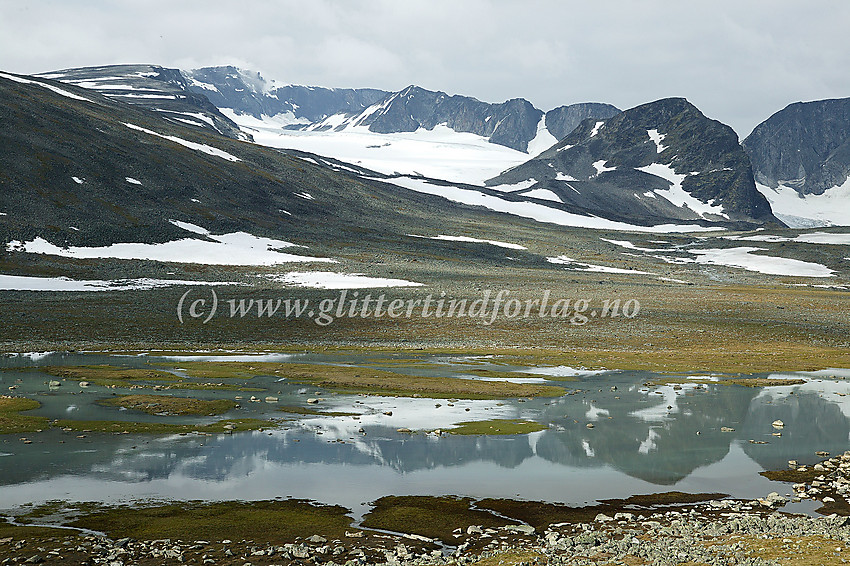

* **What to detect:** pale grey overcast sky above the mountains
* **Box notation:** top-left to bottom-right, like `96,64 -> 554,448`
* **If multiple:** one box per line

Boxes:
0,0 -> 850,137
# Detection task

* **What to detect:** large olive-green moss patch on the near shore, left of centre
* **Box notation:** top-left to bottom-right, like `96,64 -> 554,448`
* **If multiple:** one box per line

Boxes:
71,500 -> 354,544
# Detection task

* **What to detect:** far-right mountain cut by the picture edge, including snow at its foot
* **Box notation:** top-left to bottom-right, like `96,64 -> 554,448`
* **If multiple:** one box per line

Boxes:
743,98 -> 850,227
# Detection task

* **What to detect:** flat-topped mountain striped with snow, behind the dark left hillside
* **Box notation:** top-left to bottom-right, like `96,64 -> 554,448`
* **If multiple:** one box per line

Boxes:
37,65 -> 250,139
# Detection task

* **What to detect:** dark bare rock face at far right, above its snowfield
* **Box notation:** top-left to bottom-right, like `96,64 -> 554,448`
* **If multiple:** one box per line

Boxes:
743,98 -> 850,195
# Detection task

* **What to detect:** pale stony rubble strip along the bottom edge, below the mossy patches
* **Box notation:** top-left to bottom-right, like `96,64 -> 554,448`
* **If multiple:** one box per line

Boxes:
0,510 -> 850,566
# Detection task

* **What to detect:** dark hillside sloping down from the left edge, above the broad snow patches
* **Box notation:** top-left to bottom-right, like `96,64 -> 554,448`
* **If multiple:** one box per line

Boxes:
0,69 -> 510,251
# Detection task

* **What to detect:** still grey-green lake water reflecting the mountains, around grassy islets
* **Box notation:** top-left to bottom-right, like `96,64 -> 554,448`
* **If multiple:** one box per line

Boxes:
0,353 -> 850,514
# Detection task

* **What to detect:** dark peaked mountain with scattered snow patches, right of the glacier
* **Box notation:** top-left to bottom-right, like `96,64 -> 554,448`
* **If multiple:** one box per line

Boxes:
487,98 -> 776,229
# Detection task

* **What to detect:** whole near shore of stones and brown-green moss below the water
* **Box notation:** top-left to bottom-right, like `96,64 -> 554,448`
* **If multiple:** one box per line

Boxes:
8,451 -> 850,566
